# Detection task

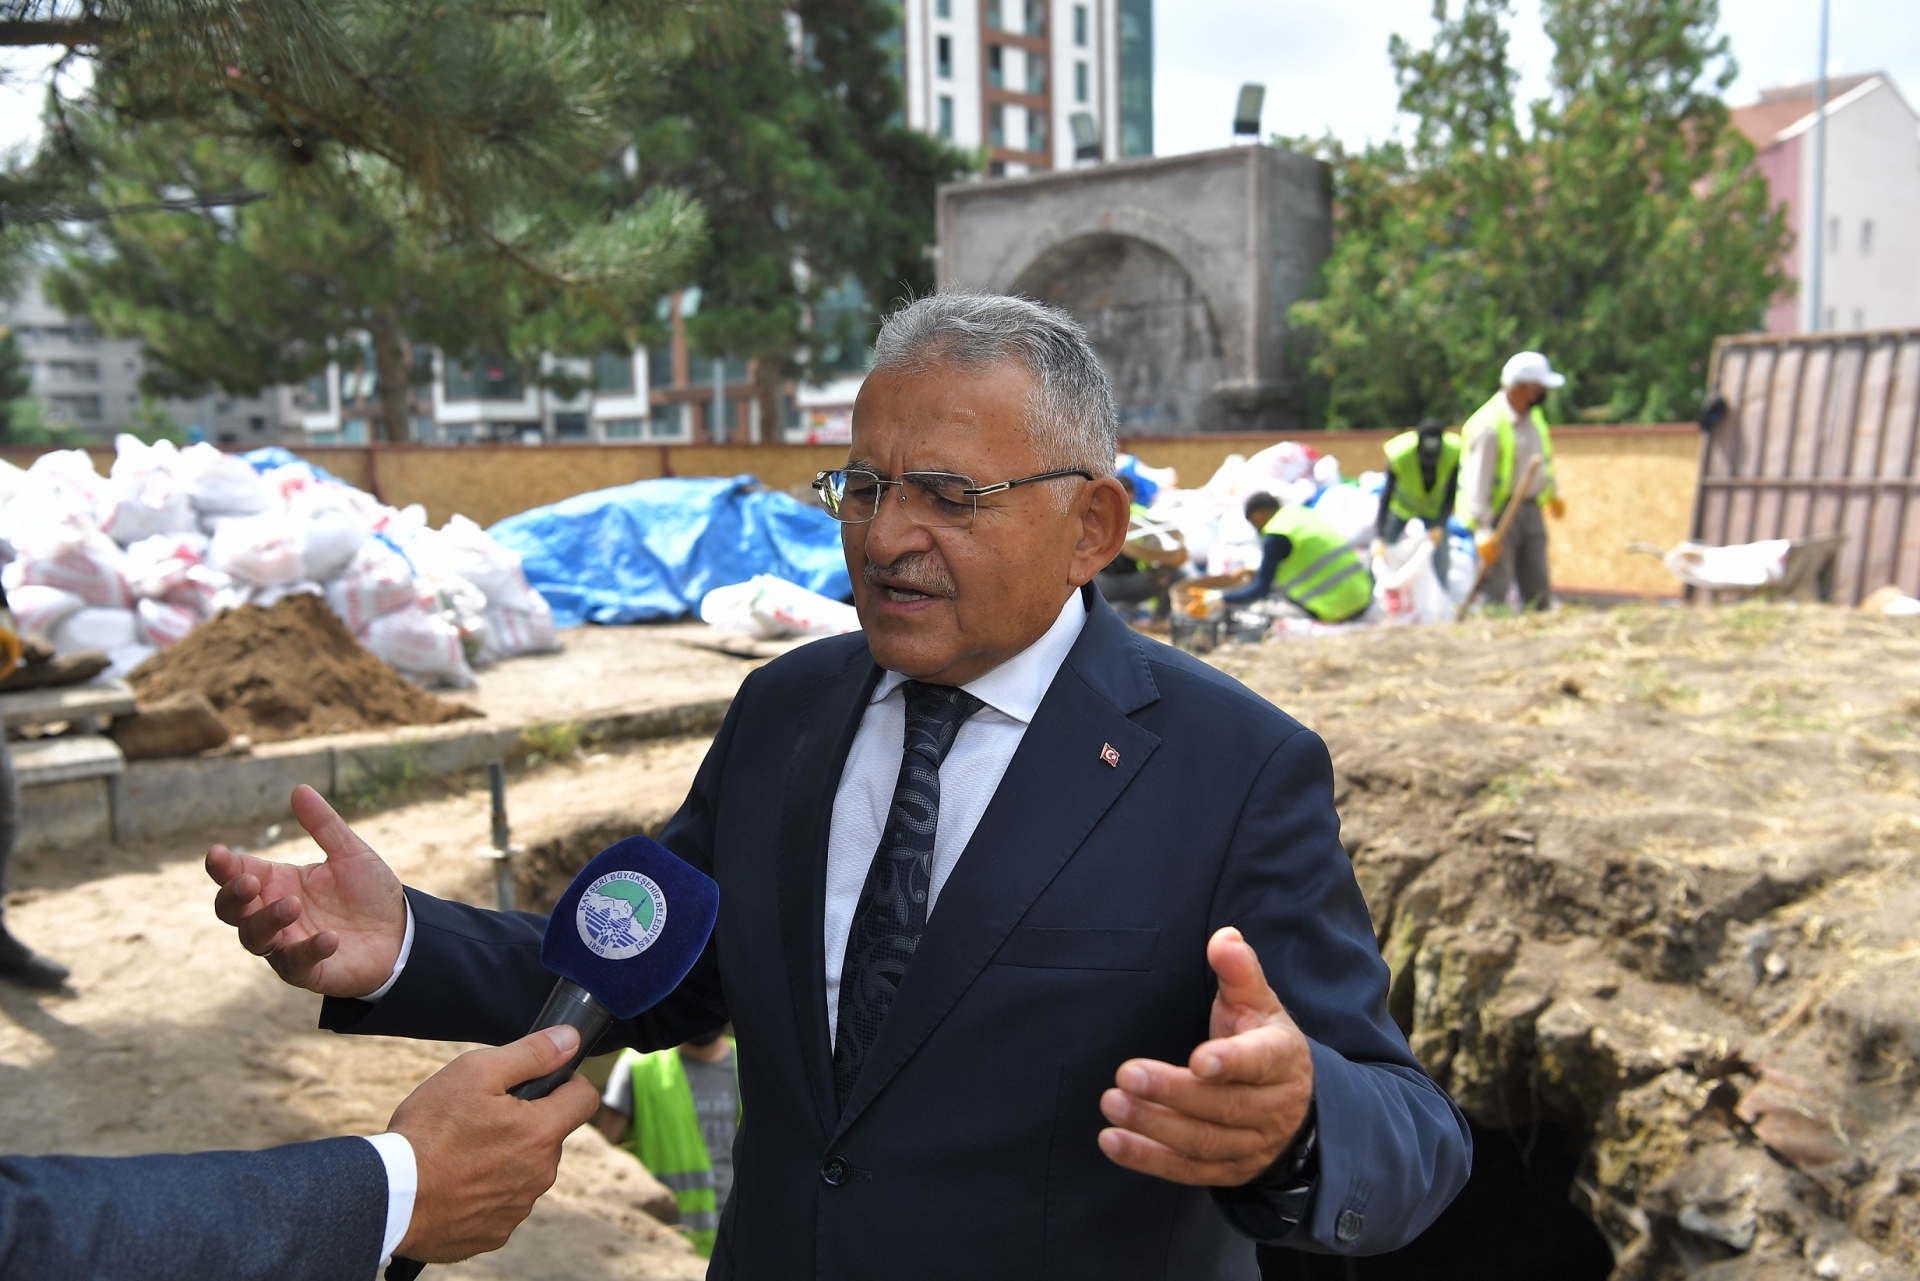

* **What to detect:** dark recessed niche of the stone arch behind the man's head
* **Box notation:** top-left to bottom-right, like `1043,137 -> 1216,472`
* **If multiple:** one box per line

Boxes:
1004,230 -> 1227,432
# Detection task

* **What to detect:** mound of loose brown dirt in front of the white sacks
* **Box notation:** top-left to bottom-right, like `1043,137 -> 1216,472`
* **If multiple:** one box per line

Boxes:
129,595 -> 480,743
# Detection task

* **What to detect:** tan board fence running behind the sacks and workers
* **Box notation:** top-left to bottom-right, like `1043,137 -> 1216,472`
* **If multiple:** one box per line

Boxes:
0,423 -> 1701,599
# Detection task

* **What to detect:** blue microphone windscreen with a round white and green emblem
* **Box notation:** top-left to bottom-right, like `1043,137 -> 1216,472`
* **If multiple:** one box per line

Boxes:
540,835 -> 720,1018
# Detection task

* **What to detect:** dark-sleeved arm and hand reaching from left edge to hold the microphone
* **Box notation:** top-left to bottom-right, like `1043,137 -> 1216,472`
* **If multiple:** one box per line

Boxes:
0,1027 -> 597,1281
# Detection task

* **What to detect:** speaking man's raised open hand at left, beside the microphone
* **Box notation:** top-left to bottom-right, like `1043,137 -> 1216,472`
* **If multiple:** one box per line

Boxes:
207,784 -> 407,998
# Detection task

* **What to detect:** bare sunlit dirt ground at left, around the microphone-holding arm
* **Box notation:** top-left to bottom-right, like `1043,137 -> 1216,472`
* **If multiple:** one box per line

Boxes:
0,737 -> 733,1281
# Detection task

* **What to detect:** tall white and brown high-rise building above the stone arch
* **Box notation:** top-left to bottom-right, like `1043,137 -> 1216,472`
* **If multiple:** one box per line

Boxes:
899,0 -> 1154,177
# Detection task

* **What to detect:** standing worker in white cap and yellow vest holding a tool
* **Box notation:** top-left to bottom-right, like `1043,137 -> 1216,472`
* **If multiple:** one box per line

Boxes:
1459,351 -> 1567,609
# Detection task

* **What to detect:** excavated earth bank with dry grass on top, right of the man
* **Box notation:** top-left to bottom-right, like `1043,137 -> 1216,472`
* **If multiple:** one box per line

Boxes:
1215,605 -> 1920,1281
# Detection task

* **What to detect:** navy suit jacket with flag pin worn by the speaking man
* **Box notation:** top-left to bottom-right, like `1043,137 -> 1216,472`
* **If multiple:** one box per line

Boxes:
323,592 -> 1471,1281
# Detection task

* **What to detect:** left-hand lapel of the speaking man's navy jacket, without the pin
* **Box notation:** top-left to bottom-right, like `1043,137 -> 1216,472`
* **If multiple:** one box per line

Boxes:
778,649 -> 879,1133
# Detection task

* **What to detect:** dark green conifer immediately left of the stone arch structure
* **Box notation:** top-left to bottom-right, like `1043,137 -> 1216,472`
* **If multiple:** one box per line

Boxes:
634,0 -> 970,420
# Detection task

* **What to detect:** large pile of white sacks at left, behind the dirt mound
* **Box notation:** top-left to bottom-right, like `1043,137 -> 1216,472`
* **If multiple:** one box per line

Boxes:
0,436 -> 559,688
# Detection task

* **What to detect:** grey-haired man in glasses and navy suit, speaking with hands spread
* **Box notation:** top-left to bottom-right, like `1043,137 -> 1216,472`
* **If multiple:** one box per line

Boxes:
209,294 -> 1469,1281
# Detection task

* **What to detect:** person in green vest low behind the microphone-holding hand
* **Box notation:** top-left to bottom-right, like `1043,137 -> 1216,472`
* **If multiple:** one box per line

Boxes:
595,1033 -> 739,1256
